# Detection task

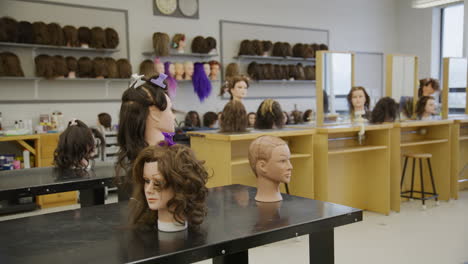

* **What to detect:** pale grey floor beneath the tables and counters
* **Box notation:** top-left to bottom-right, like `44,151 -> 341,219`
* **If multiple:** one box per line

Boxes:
0,191 -> 468,264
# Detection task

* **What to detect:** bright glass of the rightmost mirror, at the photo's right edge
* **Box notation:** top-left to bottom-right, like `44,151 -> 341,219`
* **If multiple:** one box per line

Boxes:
444,58 -> 468,115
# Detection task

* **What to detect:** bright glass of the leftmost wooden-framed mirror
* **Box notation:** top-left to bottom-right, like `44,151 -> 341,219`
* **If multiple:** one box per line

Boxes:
323,53 -> 353,122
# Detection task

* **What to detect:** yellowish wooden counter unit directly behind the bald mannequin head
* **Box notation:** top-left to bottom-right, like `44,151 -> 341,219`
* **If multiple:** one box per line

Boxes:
188,128 -> 315,198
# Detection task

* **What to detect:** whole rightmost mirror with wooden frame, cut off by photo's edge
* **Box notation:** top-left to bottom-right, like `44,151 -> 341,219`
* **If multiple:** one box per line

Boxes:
442,58 -> 468,118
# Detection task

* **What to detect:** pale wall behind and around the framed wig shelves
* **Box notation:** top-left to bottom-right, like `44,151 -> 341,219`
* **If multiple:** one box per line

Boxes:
0,0 -> 398,128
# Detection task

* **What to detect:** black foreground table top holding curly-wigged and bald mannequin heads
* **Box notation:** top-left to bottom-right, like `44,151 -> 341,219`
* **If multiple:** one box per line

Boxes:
0,185 -> 362,264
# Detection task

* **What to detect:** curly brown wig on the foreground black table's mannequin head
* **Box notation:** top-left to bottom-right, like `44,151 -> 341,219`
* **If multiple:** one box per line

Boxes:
130,145 -> 208,226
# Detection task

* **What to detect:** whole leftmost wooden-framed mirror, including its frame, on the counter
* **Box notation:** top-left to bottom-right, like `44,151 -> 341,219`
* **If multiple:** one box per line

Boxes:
316,51 -> 354,126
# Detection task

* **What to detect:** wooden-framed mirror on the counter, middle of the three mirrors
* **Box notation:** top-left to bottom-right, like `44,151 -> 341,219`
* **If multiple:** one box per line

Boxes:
385,55 -> 418,120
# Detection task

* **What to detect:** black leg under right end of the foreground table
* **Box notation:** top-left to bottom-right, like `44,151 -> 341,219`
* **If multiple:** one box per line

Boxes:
309,229 -> 335,263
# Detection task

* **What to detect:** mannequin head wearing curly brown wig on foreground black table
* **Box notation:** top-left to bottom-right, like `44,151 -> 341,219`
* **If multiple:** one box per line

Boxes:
131,144 -> 208,231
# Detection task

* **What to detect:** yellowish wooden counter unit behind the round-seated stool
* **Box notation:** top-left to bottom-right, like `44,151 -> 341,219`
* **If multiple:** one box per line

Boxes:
390,120 -> 454,212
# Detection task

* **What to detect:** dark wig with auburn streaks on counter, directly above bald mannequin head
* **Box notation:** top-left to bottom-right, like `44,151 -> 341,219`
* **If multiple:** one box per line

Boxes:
255,99 -> 283,129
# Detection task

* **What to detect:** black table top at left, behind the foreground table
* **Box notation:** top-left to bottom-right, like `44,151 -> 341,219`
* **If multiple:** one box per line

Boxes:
0,162 -> 115,200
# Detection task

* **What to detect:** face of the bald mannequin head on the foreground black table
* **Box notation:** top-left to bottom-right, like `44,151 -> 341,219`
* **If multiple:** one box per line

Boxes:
259,145 -> 293,183
